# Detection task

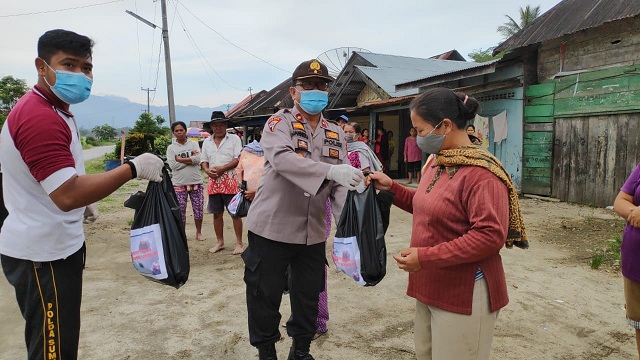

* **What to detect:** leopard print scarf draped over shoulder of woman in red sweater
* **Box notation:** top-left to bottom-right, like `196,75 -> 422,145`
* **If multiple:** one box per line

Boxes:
427,146 -> 529,249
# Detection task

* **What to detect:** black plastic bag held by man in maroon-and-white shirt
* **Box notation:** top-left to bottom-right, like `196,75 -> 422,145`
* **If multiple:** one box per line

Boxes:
125,167 -> 190,289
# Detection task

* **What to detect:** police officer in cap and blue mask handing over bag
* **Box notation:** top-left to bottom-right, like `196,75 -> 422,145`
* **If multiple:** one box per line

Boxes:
242,59 -> 363,360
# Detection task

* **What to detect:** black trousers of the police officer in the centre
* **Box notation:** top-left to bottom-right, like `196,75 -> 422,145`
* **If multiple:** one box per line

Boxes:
242,232 -> 325,347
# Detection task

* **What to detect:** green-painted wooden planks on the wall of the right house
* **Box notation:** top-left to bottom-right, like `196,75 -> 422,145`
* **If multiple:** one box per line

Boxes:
522,65 -> 640,201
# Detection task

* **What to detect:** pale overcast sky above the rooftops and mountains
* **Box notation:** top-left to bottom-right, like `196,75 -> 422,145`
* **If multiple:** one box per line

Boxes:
0,0 -> 559,107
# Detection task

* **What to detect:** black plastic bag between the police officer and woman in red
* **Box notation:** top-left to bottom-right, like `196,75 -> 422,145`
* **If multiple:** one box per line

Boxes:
331,186 -> 393,286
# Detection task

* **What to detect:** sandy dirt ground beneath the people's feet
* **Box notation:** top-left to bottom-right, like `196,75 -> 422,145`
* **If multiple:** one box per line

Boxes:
0,181 -> 636,360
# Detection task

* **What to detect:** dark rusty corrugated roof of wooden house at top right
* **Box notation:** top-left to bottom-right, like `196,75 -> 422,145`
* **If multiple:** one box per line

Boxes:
493,0 -> 640,54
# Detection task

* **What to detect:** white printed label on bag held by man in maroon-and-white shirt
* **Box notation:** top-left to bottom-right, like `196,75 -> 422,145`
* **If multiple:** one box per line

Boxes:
131,224 -> 168,280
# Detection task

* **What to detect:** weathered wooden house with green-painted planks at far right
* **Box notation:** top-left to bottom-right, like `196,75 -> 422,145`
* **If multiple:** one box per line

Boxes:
494,0 -> 640,206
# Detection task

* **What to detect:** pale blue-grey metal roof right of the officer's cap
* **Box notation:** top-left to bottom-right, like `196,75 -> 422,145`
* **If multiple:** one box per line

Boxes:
356,53 -> 478,97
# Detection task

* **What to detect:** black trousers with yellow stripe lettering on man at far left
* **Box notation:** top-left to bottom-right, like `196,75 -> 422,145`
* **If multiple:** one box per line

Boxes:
0,245 -> 85,360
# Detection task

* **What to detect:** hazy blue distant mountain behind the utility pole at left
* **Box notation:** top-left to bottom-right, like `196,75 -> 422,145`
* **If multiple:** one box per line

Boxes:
71,95 -> 235,130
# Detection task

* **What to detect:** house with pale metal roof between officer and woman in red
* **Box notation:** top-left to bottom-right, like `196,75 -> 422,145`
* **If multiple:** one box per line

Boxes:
326,50 -> 477,177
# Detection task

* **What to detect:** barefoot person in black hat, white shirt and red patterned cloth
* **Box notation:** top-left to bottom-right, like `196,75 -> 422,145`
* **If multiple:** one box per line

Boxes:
200,111 -> 242,255
